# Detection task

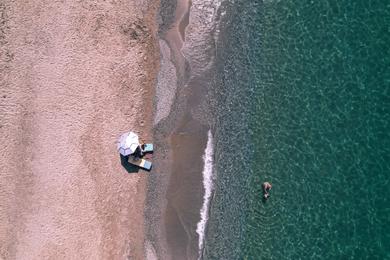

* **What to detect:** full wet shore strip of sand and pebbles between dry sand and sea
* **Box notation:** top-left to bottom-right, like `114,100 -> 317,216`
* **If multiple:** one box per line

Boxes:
145,0 -> 219,259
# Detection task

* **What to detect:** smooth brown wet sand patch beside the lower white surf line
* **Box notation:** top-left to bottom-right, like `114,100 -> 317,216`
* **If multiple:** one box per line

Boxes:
165,117 -> 208,259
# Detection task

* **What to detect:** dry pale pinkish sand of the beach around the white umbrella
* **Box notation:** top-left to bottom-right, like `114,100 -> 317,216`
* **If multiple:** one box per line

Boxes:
0,0 -> 159,259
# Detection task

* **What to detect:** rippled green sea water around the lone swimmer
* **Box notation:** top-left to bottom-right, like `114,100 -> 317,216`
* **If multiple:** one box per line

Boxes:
204,0 -> 390,259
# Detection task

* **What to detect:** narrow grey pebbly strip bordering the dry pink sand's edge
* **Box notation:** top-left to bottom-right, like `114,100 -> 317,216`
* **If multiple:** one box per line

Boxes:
145,1 -> 193,259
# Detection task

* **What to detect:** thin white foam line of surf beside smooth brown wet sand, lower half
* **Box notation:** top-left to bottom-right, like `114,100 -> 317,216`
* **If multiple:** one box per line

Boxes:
196,130 -> 214,259
